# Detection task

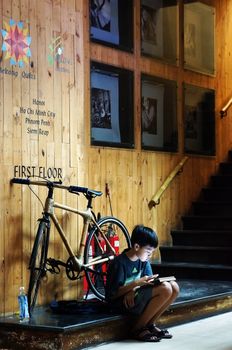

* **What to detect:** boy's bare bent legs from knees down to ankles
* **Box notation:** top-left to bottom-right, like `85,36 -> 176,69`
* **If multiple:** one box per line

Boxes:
134,282 -> 179,330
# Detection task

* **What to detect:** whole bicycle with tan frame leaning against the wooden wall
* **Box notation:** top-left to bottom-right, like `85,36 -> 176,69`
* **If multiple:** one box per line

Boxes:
11,178 -> 131,315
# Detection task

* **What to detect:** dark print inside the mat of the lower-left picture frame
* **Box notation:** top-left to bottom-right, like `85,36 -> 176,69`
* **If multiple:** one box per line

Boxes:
91,88 -> 112,129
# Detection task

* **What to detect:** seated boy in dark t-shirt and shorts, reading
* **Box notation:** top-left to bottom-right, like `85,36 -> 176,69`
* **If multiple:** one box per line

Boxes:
106,225 -> 179,342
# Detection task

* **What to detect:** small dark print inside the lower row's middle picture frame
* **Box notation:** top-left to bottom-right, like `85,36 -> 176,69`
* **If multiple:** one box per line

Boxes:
142,97 -> 157,135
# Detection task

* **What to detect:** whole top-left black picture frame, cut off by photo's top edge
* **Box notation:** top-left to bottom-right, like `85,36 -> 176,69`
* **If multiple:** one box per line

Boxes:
89,0 -> 134,52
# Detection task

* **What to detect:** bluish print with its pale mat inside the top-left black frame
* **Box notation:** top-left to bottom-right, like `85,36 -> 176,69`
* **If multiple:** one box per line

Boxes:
90,0 -> 119,45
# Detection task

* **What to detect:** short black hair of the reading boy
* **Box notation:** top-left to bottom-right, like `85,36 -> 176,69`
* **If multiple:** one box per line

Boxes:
131,225 -> 158,248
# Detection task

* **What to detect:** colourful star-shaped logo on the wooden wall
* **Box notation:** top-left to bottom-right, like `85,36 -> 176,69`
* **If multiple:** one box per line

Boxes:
1,19 -> 31,68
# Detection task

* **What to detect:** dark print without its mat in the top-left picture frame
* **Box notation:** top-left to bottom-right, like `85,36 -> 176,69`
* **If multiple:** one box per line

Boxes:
90,0 -> 111,32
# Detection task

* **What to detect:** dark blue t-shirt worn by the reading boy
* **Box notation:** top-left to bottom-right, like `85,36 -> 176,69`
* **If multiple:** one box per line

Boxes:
106,251 -> 152,301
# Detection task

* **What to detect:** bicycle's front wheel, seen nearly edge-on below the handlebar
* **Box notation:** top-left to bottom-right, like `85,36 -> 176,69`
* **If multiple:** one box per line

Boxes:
28,220 -> 49,315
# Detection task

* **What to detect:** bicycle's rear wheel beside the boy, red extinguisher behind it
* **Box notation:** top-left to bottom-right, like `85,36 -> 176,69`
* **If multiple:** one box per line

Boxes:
84,216 -> 131,300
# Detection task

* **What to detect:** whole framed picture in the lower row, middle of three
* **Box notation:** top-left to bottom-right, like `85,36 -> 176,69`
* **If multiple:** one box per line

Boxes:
141,74 -> 178,152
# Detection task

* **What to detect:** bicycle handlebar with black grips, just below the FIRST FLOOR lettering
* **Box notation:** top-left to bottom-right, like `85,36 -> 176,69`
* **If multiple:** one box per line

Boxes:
10,177 -> 102,196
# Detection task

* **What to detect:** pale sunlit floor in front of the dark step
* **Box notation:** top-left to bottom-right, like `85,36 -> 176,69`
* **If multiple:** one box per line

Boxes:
88,312 -> 232,350
